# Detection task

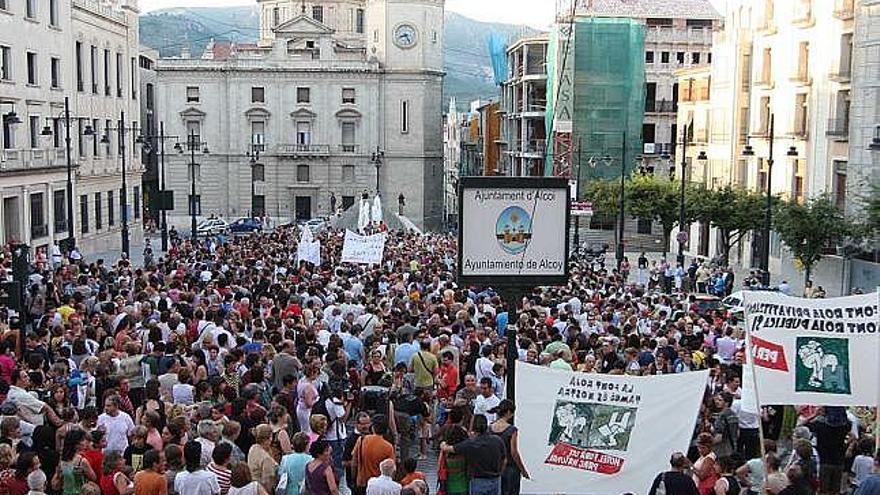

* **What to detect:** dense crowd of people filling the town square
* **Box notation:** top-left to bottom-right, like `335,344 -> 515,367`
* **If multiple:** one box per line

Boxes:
0,227 -> 878,495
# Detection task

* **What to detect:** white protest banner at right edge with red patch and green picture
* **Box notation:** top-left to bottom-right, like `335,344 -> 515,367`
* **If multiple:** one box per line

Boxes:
743,292 -> 880,406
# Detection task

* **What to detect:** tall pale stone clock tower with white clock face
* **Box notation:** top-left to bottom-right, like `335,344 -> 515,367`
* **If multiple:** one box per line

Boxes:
366,0 -> 445,229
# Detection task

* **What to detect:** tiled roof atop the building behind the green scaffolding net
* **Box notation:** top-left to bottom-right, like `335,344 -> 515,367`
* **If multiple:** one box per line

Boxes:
577,0 -> 721,20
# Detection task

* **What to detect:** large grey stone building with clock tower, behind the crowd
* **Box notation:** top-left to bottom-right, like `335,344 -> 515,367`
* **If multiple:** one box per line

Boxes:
157,0 -> 444,232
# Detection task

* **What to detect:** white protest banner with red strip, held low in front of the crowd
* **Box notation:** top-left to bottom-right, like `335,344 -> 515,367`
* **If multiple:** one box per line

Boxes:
516,362 -> 709,495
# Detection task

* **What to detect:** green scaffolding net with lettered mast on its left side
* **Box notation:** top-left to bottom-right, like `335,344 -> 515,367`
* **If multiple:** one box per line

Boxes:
545,17 -> 645,184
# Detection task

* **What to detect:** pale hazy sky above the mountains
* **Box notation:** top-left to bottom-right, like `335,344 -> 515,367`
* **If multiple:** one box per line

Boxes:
140,0 -> 556,28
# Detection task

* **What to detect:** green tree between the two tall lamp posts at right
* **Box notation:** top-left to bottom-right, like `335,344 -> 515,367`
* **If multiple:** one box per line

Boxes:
692,186 -> 766,264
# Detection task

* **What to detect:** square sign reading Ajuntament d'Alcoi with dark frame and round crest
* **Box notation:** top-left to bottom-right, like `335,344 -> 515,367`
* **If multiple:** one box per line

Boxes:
459,177 -> 569,285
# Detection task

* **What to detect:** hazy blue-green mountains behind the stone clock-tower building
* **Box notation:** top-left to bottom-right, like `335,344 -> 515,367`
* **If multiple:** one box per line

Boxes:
140,7 -> 538,110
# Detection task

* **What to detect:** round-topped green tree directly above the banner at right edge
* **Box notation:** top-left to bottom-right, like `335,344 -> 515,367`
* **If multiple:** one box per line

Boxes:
773,196 -> 852,281
